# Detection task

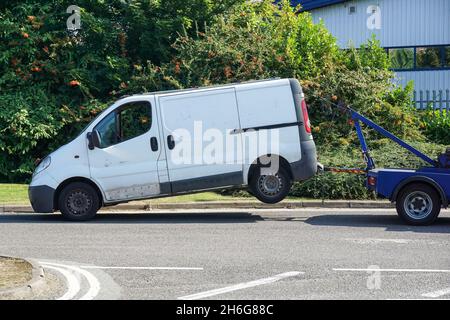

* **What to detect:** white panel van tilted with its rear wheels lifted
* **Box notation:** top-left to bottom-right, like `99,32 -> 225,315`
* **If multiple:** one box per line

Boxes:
29,79 -> 317,220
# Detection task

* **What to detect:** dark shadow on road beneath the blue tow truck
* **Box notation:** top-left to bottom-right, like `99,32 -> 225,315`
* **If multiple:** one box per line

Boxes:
305,214 -> 450,233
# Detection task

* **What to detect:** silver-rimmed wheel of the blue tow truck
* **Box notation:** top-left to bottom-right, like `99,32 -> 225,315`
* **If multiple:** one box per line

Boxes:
396,183 -> 442,226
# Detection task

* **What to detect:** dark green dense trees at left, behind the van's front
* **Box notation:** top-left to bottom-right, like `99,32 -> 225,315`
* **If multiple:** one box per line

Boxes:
0,0 -> 243,182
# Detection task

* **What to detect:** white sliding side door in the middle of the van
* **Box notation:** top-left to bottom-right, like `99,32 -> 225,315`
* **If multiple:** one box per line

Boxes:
159,88 -> 243,193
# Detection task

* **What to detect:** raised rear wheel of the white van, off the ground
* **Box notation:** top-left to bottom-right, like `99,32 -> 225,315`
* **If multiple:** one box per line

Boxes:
249,167 -> 292,204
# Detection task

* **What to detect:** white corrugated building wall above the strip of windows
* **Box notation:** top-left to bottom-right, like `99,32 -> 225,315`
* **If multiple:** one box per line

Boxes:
311,0 -> 450,48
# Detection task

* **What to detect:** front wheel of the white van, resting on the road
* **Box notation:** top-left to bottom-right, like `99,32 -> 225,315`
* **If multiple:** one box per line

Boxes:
58,182 -> 100,221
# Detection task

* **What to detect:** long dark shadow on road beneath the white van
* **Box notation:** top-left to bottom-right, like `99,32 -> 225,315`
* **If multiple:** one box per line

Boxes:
0,212 -> 264,224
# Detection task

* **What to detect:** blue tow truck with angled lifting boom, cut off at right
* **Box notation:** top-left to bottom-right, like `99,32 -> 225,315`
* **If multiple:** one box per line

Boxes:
325,106 -> 450,225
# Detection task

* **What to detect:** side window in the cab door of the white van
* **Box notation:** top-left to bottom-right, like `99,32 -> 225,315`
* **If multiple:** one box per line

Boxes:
95,101 -> 152,148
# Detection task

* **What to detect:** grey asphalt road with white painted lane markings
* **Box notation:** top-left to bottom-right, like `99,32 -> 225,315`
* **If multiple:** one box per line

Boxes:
0,208 -> 450,299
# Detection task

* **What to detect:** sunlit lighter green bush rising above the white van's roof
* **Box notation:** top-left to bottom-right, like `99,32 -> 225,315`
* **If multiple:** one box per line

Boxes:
158,0 -> 338,87
